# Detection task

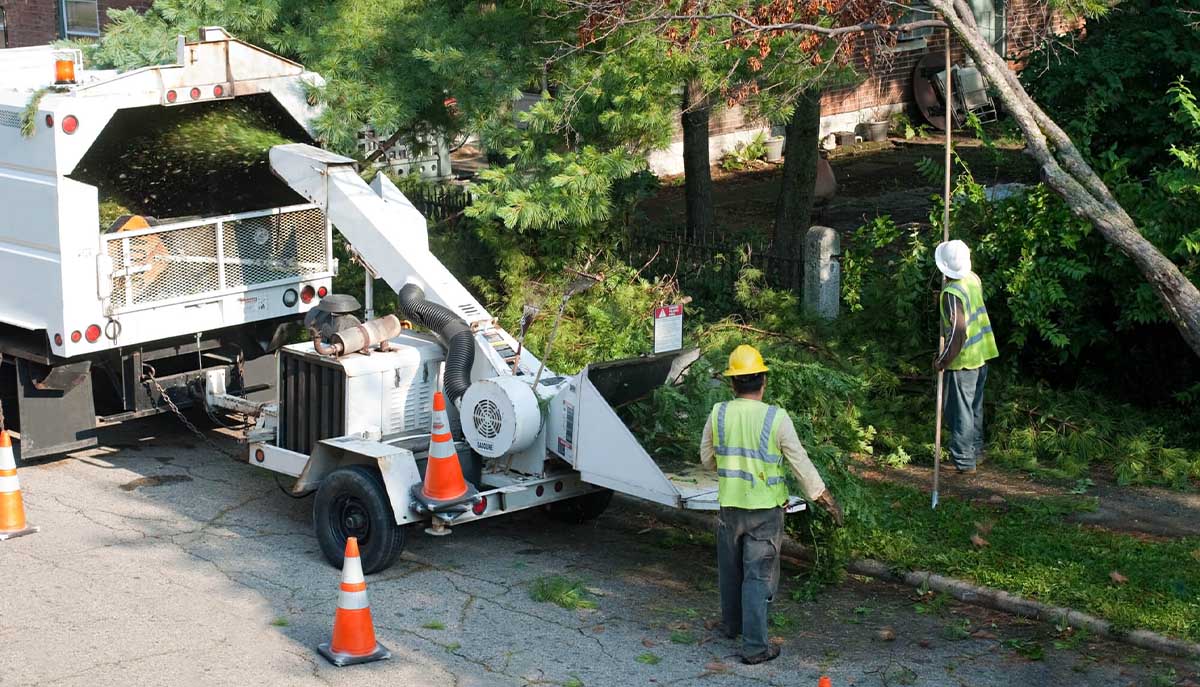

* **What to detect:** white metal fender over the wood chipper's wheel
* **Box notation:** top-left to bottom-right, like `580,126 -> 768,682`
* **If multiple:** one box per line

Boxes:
293,436 -> 421,525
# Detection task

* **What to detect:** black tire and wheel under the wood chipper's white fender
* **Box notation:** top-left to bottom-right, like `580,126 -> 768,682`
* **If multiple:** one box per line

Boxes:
312,465 -> 404,574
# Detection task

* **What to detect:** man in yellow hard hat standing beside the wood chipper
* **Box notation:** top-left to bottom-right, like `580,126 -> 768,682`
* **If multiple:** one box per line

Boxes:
700,345 -> 842,665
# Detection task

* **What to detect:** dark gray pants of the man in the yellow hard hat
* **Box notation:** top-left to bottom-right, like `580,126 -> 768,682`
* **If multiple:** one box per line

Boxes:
716,508 -> 784,656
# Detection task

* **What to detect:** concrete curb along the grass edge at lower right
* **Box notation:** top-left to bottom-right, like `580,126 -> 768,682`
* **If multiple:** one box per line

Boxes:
616,494 -> 1200,659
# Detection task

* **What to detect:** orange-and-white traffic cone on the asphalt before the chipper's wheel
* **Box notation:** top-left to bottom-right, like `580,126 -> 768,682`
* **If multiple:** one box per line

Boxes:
317,537 -> 391,668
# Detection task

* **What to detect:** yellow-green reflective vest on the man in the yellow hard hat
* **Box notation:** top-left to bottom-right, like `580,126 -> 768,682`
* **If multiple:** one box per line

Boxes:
712,399 -> 787,509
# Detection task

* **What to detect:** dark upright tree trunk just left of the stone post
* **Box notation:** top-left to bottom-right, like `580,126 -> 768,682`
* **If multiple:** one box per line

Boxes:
773,89 -> 821,288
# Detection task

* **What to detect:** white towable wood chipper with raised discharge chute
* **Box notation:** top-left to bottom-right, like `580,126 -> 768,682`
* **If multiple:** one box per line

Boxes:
208,144 -> 806,572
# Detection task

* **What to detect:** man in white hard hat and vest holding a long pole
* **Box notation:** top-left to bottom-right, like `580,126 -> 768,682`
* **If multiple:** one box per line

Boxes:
934,240 -> 1000,474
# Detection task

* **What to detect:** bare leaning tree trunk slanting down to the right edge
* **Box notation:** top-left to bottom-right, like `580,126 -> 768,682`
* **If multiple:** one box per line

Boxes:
930,0 -> 1200,356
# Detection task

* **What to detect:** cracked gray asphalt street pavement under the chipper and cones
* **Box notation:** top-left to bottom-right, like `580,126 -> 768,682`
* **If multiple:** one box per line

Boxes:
0,418 -> 1196,687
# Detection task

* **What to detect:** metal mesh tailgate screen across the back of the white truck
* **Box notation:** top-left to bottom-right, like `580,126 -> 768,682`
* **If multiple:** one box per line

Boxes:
107,208 -> 330,310
